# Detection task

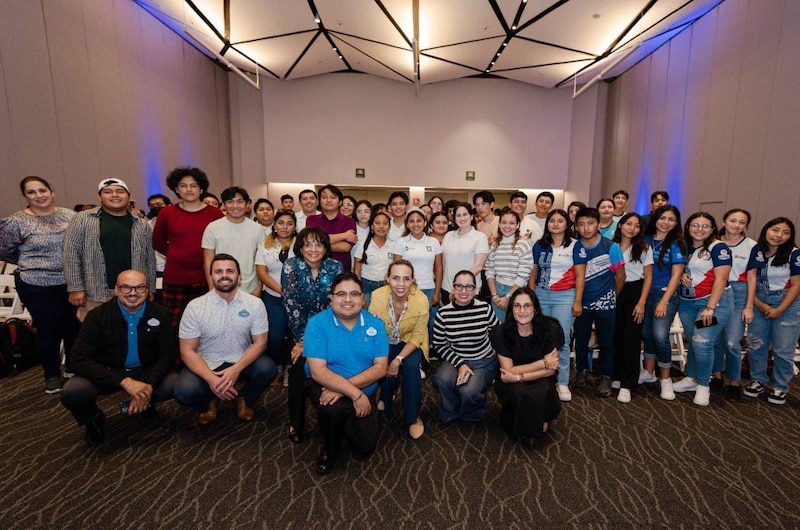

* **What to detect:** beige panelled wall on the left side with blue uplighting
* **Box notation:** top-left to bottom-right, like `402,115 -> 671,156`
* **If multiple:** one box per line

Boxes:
0,0 -> 231,216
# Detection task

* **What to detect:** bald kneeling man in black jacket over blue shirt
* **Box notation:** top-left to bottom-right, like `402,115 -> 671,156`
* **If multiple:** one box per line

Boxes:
61,270 -> 178,445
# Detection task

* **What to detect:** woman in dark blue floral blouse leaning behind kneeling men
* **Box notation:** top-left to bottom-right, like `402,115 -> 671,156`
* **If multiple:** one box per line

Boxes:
281,227 -> 344,443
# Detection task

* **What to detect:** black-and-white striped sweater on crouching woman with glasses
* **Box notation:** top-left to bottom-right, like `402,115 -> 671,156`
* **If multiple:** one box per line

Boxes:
433,299 -> 500,368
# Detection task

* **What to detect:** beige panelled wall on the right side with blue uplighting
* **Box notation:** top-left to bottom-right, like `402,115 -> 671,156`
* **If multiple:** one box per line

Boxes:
602,0 -> 800,229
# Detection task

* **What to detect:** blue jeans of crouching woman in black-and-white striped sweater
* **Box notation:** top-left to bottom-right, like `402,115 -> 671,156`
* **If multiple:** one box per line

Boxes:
433,355 -> 498,423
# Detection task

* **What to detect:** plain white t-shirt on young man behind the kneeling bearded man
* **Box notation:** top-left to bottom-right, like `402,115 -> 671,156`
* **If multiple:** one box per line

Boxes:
202,217 -> 266,293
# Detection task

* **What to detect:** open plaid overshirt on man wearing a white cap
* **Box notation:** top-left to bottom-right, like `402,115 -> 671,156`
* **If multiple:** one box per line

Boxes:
62,206 -> 156,302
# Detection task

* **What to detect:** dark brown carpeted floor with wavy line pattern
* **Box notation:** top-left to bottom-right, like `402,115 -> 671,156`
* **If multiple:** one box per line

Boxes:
0,369 -> 800,529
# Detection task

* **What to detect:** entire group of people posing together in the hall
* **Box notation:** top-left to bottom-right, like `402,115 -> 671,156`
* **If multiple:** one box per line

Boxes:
0,167 -> 800,474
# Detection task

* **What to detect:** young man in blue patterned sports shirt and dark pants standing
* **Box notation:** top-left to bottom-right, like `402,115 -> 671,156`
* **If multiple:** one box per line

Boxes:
572,208 -> 625,397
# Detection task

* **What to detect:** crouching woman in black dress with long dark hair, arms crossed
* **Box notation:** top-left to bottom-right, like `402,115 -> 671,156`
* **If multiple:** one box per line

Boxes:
491,286 -> 565,440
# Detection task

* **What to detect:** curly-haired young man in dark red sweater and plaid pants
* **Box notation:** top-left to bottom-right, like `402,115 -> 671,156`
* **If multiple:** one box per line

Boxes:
153,167 -> 224,329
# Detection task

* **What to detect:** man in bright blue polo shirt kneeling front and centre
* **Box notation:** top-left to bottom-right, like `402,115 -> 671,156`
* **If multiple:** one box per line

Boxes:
303,272 -> 389,475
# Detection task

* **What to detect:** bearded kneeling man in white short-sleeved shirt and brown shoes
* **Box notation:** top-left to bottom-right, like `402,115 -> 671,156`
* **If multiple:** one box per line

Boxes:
175,254 -> 278,426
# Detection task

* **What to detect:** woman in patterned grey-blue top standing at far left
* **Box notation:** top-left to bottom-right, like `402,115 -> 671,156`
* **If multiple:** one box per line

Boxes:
0,177 -> 80,394
